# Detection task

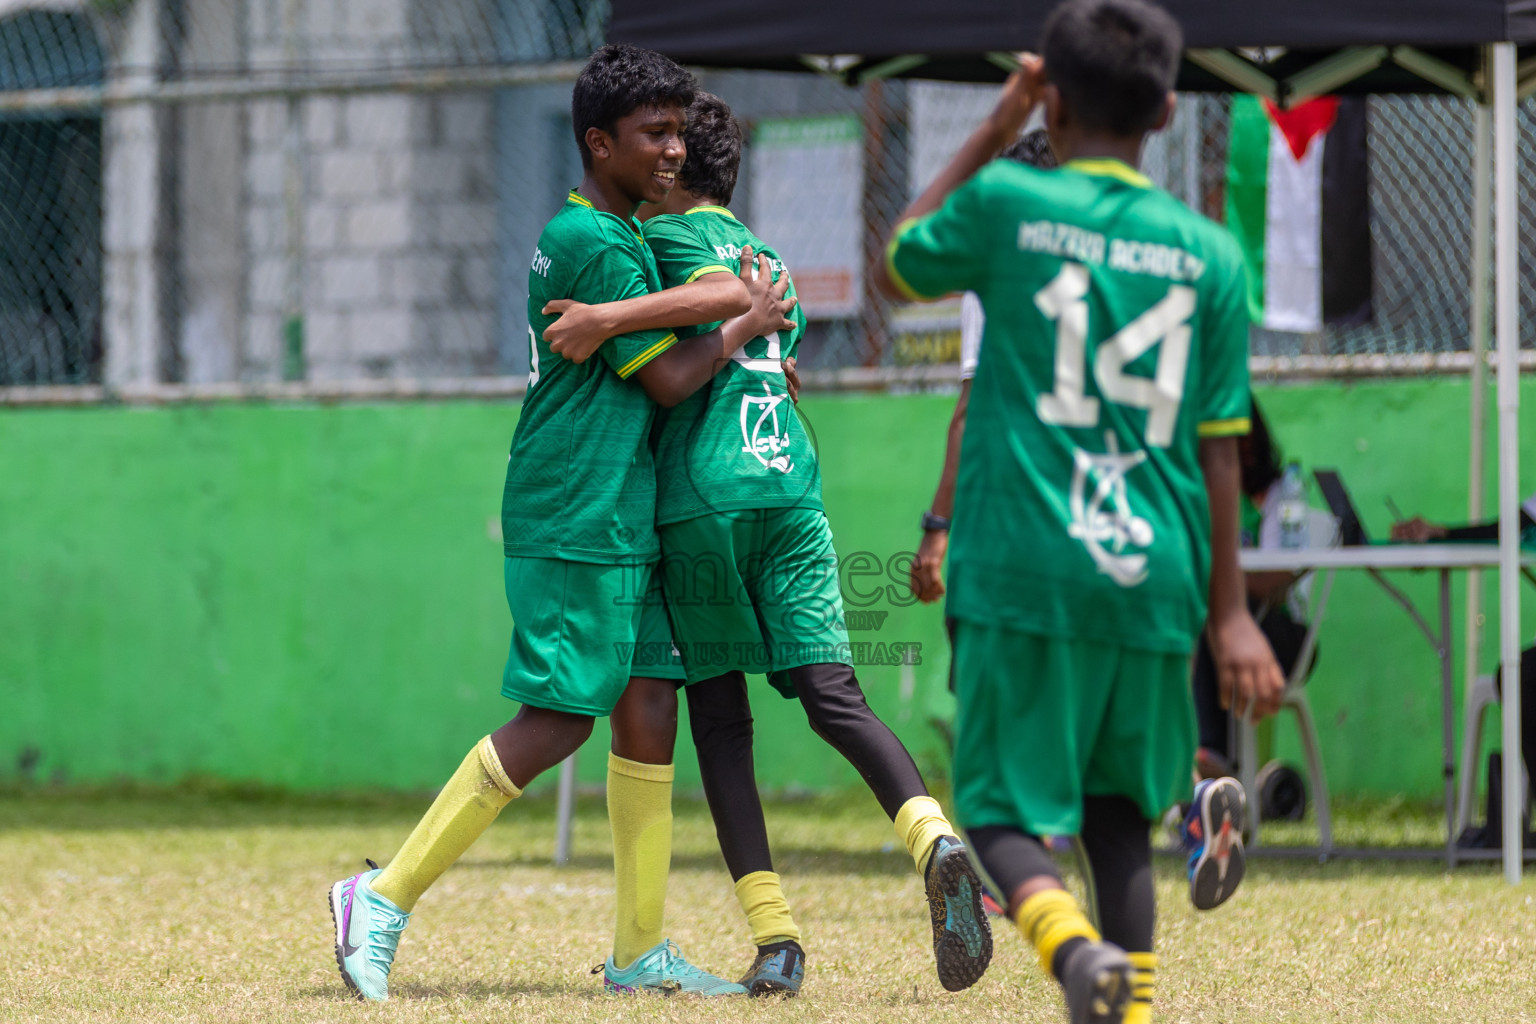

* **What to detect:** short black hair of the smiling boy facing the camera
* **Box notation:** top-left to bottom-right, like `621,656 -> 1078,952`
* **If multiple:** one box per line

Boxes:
571,43 -> 699,167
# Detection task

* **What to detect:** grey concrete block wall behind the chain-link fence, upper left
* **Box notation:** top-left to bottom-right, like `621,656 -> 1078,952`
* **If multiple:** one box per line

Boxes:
103,0 -> 502,385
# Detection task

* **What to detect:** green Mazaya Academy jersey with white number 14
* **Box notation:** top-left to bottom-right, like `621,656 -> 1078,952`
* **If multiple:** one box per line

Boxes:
886,160 -> 1249,652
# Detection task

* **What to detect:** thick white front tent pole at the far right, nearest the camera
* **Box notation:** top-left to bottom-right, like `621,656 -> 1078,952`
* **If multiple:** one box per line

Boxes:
1491,43 -> 1524,884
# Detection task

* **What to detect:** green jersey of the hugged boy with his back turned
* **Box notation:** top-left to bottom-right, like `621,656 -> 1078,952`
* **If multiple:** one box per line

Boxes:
644,206 -> 822,524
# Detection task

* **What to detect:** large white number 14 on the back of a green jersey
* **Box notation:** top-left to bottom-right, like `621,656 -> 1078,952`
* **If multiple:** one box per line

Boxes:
1035,263 -> 1195,448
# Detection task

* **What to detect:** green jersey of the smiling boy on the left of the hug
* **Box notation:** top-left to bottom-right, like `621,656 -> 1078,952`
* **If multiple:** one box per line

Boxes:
501,192 -> 677,563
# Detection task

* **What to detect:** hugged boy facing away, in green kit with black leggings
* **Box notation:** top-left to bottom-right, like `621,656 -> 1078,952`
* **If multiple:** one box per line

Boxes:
540,94 -> 992,995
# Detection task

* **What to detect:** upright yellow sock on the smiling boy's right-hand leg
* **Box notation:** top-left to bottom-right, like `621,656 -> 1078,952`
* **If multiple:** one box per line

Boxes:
608,754 -> 673,967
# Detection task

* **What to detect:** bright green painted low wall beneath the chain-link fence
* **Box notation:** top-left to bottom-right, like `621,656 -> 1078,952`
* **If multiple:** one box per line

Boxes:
0,381 -> 1536,795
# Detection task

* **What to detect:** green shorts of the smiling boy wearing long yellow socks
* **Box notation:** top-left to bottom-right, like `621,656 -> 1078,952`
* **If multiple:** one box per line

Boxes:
501,557 -> 682,717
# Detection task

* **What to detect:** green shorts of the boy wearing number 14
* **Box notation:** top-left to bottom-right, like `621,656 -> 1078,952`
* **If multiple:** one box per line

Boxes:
954,622 -> 1195,835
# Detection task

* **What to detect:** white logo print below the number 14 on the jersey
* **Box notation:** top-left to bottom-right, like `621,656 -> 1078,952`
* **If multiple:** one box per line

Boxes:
1066,430 -> 1154,586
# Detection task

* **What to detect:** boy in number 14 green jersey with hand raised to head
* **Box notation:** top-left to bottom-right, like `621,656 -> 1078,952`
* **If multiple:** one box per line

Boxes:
872,0 -> 1284,1022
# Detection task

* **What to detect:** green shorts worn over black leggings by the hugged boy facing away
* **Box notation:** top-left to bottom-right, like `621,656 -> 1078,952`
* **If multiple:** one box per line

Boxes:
656,508 -> 851,697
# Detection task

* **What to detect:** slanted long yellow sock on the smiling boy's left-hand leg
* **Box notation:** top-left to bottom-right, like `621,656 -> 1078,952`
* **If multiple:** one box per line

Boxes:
370,735 -> 522,913
